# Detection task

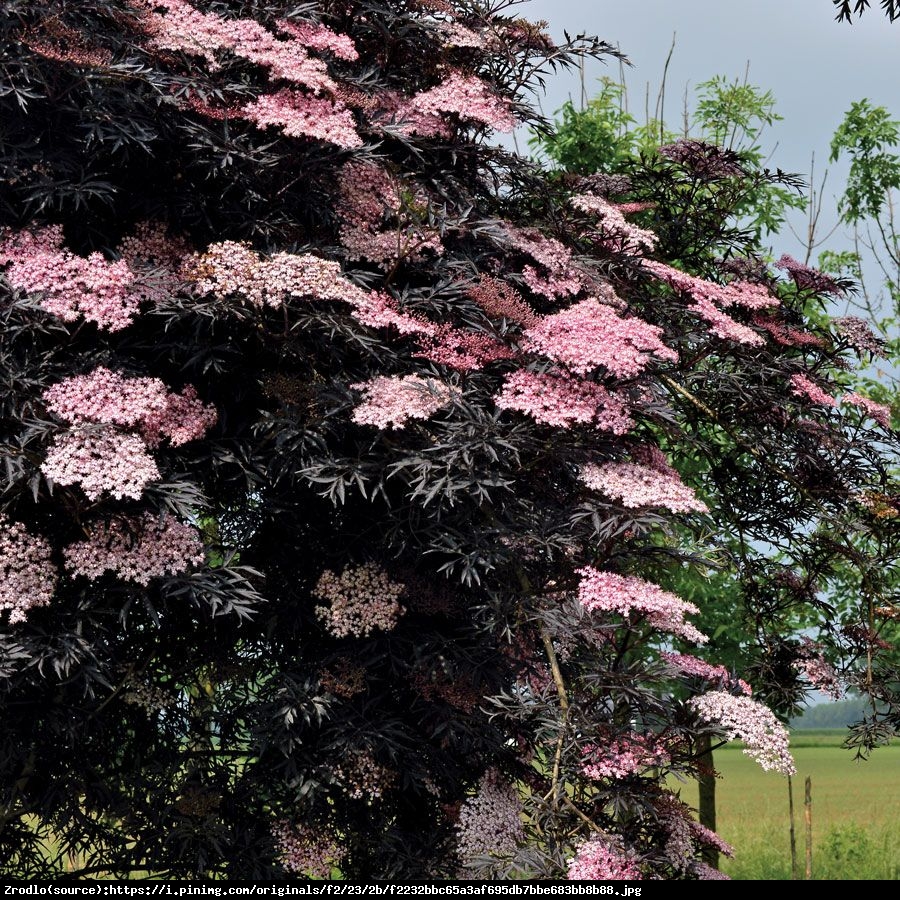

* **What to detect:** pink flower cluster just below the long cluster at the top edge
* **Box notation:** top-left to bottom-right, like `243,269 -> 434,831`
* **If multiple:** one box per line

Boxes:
240,88 -> 363,150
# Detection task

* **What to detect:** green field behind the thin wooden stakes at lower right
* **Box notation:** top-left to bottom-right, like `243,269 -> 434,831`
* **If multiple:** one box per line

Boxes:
680,731 -> 900,880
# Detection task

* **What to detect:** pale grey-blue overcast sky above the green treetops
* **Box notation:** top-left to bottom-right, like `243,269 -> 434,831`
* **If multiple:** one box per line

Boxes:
518,0 -> 900,264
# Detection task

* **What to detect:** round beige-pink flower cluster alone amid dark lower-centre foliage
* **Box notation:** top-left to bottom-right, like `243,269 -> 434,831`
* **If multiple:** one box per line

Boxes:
312,563 -> 406,637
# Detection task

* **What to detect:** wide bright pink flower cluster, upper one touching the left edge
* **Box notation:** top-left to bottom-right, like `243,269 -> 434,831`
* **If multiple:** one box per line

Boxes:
0,226 -> 145,331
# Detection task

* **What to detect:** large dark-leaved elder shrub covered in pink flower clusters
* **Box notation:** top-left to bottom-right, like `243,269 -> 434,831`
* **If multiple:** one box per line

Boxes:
0,0 -> 896,879
